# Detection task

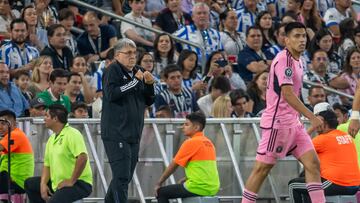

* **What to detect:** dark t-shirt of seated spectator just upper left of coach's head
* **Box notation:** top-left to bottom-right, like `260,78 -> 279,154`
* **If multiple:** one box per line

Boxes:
77,25 -> 116,56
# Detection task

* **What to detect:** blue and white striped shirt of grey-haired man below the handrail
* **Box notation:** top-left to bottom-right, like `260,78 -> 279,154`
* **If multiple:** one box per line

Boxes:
174,24 -> 223,62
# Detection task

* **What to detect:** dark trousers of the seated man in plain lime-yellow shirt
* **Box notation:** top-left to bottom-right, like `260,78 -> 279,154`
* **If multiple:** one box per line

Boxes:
25,177 -> 92,203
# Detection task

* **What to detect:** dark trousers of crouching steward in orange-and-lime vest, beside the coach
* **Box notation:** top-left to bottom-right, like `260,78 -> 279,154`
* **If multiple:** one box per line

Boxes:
157,184 -> 199,203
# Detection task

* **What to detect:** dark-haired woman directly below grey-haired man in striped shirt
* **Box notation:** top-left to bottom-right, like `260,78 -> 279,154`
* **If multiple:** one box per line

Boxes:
177,49 -> 207,98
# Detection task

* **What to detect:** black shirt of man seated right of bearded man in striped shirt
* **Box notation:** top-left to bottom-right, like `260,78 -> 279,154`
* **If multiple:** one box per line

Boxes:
40,45 -> 74,71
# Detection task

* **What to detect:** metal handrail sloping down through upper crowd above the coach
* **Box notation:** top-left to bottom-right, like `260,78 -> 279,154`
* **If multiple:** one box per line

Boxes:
66,0 -> 206,70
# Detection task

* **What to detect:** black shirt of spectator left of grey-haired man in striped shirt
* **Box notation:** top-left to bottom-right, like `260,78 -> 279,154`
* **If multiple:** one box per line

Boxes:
155,8 -> 192,33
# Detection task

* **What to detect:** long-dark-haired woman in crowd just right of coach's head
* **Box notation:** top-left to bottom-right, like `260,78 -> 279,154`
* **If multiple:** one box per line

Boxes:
154,33 -> 177,77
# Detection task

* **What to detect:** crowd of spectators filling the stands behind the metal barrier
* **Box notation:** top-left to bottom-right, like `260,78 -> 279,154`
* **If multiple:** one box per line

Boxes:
0,0 -> 360,122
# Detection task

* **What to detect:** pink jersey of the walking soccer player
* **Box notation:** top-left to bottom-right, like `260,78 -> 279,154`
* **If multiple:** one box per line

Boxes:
260,49 -> 303,129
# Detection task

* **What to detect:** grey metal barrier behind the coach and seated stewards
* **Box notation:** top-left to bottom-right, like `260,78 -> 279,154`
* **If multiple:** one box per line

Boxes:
18,118 -> 301,203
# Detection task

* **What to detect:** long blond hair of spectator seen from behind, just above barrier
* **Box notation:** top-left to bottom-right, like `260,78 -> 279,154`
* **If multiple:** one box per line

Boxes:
211,95 -> 232,118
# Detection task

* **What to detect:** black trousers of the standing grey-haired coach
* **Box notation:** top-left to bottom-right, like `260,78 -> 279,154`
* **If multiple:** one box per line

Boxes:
103,140 -> 139,203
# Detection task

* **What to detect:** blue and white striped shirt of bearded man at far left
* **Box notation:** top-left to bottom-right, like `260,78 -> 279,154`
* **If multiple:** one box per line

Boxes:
0,41 -> 40,69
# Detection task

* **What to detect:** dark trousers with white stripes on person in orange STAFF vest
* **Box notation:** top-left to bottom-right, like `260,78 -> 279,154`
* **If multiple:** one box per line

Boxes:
289,177 -> 359,203
